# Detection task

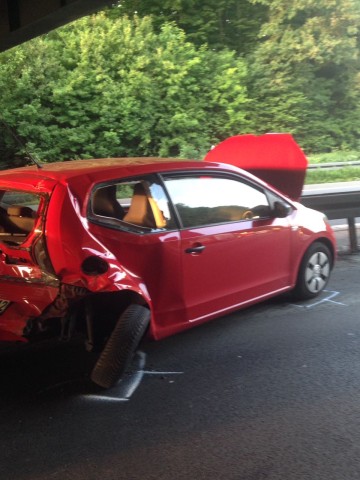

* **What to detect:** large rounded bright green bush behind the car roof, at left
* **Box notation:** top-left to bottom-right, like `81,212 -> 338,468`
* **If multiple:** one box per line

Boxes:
0,14 -> 247,160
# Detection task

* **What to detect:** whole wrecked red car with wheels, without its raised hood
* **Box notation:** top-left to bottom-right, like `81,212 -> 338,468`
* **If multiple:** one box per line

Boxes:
0,158 -> 336,387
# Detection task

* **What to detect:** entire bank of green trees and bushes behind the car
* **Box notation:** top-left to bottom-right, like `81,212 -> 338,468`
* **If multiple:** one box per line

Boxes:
0,0 -> 360,161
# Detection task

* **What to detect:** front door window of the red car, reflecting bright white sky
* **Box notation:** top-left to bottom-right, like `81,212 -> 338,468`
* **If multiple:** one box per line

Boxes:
165,175 -> 270,227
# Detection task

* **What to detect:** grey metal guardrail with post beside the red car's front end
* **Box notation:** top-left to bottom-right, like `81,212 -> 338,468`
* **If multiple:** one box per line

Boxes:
300,182 -> 360,252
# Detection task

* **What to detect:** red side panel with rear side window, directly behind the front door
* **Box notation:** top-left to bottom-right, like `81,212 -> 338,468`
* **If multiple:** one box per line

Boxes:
89,175 -> 191,338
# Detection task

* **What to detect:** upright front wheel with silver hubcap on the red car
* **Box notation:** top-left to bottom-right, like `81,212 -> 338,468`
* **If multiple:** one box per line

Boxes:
294,242 -> 333,300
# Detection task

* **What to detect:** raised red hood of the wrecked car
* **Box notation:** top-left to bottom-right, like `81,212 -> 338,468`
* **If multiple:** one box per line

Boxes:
204,133 -> 308,200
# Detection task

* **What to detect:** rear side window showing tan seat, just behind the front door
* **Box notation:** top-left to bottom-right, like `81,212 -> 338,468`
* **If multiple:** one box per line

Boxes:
90,178 -> 175,233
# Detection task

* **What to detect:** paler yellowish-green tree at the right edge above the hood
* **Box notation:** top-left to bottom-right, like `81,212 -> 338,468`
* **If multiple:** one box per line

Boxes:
248,0 -> 360,151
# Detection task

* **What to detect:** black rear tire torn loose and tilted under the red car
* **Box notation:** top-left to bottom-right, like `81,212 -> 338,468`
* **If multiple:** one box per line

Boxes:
91,304 -> 150,388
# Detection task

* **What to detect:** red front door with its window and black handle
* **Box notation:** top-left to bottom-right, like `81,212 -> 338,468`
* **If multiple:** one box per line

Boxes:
164,173 -> 291,322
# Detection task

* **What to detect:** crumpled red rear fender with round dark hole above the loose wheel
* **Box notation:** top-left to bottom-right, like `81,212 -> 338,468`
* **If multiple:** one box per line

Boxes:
46,184 -> 151,314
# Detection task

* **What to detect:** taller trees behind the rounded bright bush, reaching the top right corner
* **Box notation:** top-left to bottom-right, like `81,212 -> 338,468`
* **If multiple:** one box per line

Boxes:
111,0 -> 360,151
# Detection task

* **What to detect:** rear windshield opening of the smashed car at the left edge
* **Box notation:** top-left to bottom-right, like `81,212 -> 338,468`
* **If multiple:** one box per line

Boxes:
0,190 -> 41,245
